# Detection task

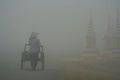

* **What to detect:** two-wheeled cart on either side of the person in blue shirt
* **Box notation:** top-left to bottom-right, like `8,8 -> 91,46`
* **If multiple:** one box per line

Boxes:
21,44 -> 45,70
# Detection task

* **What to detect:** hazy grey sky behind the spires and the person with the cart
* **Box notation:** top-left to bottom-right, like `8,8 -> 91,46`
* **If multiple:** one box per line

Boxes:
0,0 -> 120,62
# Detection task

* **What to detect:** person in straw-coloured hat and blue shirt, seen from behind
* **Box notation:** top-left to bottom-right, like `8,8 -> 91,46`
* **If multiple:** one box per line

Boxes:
29,32 -> 41,70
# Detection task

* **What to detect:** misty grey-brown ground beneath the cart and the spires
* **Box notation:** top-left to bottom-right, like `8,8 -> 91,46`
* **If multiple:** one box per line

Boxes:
0,53 -> 120,80
